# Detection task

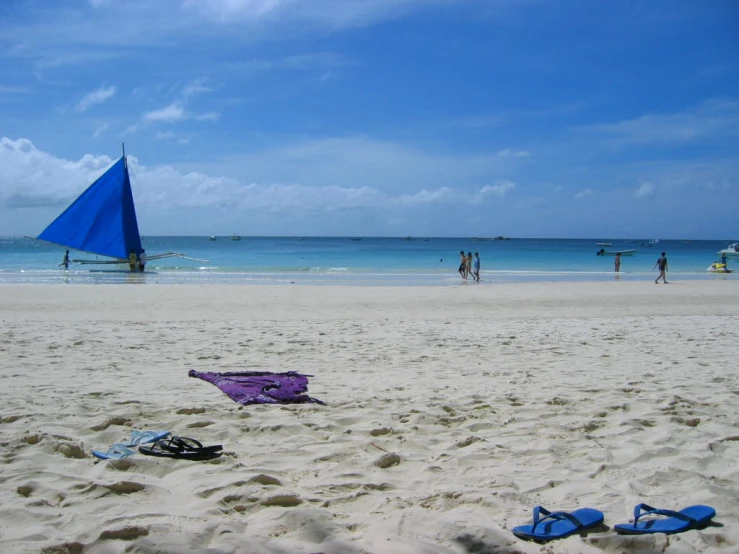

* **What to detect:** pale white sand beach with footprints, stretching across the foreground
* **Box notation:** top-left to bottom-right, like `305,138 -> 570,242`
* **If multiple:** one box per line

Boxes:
0,280 -> 739,554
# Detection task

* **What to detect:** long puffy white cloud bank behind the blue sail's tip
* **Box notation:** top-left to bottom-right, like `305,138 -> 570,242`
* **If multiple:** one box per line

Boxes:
0,136 -> 515,224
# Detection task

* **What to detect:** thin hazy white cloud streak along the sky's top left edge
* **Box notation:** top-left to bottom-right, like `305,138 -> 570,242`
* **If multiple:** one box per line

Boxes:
3,0 -> 466,68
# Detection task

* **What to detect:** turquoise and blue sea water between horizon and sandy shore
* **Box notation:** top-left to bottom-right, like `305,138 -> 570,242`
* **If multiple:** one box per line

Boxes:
0,236 -> 739,286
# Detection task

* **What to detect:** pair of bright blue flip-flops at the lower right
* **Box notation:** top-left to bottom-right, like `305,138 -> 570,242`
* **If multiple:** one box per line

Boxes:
512,504 -> 716,542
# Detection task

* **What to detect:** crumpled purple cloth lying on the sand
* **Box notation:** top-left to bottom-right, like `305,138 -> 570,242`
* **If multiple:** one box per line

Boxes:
188,369 -> 324,406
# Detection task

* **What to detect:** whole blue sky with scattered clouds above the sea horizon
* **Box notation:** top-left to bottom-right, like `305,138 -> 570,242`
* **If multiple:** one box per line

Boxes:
0,0 -> 739,240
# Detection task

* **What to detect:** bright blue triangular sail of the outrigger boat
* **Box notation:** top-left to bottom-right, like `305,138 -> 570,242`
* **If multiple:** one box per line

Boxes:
36,157 -> 141,259
